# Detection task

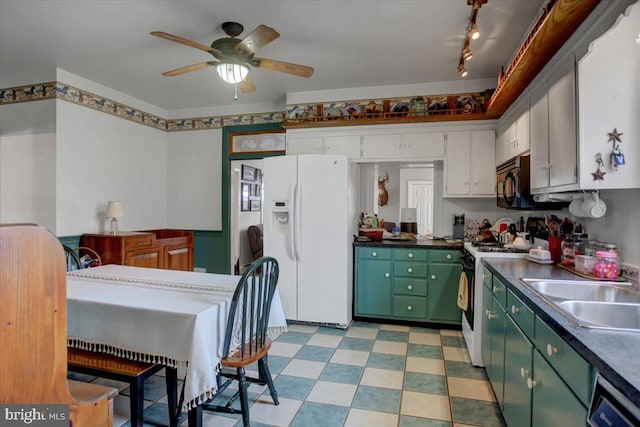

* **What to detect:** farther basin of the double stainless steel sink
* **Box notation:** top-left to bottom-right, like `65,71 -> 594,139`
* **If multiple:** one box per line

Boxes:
522,279 -> 640,304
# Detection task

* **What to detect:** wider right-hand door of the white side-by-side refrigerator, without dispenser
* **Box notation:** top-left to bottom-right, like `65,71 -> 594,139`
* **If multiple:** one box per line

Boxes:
296,155 -> 352,324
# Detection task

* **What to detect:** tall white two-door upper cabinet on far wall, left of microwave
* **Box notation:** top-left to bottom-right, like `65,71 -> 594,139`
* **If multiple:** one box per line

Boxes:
444,130 -> 496,197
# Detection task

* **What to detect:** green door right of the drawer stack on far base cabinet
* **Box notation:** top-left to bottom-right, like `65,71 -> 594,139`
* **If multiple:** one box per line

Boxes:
427,263 -> 462,325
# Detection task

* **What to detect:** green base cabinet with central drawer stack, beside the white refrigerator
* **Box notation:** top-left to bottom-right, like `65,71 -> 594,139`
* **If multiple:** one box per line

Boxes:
354,246 -> 462,325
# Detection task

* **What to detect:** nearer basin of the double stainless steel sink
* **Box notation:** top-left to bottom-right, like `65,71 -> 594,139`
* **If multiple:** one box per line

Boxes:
558,301 -> 640,332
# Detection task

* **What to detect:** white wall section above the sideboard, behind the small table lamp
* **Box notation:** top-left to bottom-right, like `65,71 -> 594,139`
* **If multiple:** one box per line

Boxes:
56,101 -> 167,236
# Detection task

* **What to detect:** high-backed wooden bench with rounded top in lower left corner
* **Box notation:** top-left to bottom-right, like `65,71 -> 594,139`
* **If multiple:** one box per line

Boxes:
0,224 -> 117,427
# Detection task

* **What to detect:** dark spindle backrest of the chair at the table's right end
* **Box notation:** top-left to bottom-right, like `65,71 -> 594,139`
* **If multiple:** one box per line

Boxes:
222,257 -> 280,359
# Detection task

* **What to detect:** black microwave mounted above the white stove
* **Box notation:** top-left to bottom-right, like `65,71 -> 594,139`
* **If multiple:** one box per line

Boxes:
496,155 -> 566,210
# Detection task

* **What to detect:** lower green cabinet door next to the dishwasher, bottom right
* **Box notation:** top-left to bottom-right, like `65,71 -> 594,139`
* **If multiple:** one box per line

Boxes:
530,350 -> 587,427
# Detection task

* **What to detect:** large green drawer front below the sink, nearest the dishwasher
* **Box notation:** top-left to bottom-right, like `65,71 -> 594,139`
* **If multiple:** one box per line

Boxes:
534,316 -> 591,406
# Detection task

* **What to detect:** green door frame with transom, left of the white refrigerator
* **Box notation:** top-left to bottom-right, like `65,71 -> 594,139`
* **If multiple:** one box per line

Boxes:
221,122 -> 284,274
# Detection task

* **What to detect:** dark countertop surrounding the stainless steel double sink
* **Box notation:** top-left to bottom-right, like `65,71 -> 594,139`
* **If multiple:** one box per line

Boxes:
483,258 -> 640,407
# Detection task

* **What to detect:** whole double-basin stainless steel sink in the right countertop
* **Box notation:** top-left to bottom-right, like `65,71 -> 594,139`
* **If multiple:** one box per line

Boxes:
520,279 -> 640,332
